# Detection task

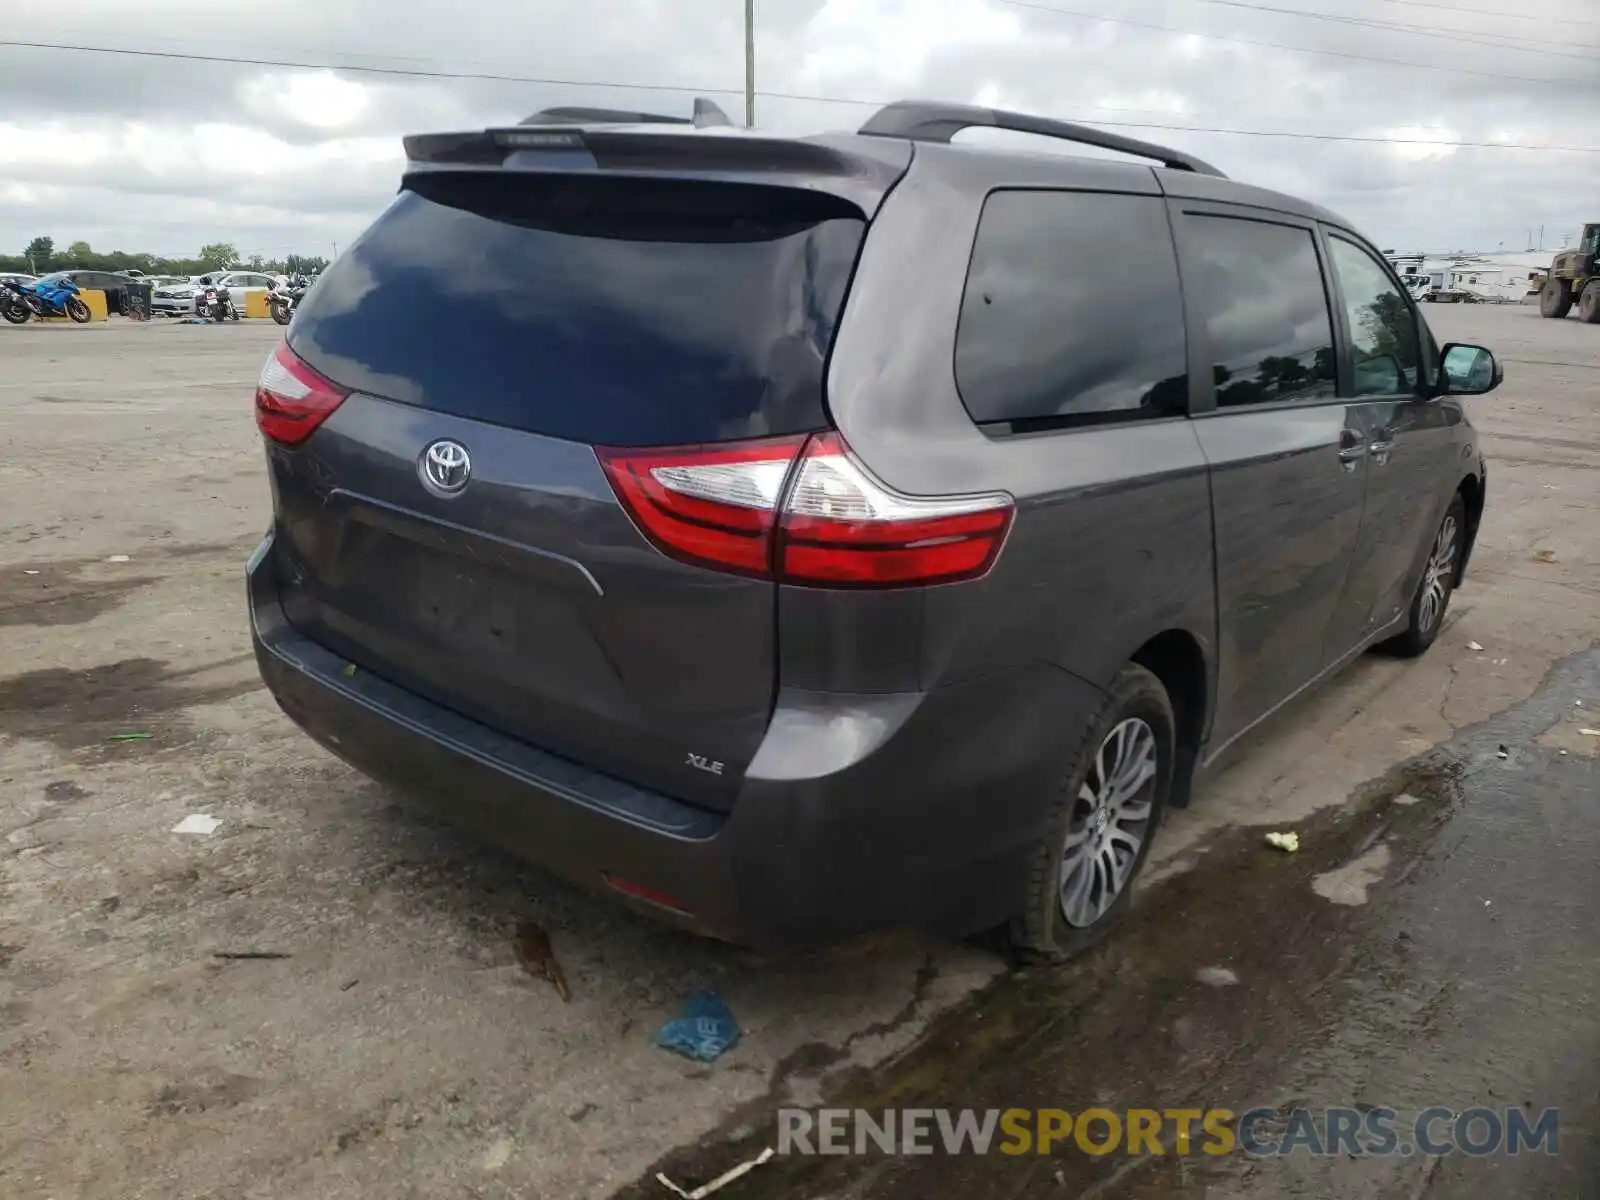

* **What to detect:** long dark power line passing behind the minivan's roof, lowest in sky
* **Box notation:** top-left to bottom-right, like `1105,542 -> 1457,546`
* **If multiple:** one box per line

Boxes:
0,37 -> 1600,154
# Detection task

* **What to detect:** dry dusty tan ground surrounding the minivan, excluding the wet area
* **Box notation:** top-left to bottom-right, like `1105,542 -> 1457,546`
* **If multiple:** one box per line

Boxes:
0,307 -> 1600,1200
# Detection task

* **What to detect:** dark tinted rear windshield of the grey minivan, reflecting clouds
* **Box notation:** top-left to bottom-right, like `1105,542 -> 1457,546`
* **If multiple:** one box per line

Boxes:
290,174 -> 866,446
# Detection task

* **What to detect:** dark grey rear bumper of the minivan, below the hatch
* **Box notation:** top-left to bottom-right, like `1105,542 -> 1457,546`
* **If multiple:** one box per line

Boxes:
248,539 -> 1098,946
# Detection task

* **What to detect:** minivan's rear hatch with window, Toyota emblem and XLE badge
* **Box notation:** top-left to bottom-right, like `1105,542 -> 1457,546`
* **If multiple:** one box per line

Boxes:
269,148 -> 889,808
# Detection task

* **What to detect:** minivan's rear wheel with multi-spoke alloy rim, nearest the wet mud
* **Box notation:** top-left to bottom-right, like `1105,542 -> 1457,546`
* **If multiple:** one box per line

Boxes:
1010,662 -> 1178,962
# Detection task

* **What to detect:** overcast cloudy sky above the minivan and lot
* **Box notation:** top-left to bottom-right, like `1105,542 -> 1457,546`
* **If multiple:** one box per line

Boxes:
0,0 -> 1600,256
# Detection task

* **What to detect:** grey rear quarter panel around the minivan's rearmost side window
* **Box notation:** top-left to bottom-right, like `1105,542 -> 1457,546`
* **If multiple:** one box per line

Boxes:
812,155 -> 1216,704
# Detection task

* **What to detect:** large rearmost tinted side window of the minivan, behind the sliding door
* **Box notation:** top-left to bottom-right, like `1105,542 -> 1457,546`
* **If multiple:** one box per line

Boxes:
955,192 -> 1189,429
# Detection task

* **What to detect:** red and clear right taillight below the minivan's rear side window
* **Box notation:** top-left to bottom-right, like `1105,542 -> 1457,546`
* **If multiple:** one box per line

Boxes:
597,434 -> 1013,587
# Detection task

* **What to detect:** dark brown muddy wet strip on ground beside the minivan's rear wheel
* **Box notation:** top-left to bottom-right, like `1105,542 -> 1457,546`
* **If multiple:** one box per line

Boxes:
618,755 -> 1461,1200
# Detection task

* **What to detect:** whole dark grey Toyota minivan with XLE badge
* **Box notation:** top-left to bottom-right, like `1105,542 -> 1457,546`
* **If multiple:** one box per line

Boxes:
248,102 -> 1501,957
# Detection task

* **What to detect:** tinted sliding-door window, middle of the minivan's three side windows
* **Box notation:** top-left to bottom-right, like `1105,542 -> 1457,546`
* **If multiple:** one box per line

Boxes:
1184,213 -> 1338,406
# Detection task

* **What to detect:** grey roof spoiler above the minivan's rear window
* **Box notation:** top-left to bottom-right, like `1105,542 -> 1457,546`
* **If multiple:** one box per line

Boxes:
402,124 -> 912,219
